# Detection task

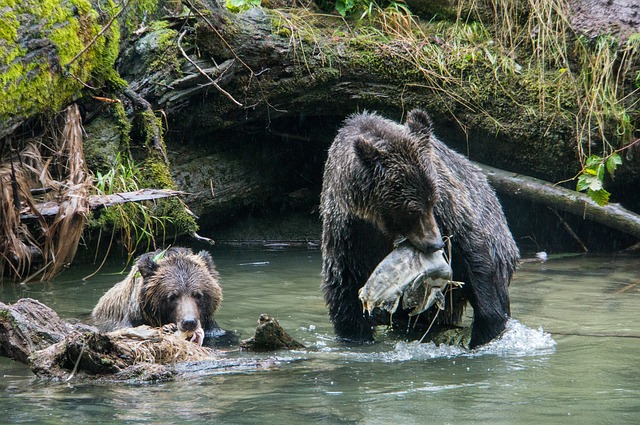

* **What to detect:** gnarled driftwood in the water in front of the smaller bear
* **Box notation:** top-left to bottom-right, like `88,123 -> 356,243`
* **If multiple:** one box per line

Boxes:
0,298 -> 303,381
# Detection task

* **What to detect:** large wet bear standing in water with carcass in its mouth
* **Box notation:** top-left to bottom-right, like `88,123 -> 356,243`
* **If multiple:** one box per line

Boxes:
321,109 -> 519,348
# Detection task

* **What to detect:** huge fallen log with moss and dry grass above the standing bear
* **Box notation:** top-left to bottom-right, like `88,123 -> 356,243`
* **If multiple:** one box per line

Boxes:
119,0 -> 632,180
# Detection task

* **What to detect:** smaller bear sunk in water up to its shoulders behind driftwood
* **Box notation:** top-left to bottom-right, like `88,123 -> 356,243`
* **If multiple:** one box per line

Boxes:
91,248 -> 224,344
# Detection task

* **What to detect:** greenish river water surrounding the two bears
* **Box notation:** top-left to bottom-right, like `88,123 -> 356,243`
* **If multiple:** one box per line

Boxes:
0,249 -> 640,425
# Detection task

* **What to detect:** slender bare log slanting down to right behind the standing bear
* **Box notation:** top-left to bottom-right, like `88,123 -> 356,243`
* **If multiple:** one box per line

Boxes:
476,163 -> 640,238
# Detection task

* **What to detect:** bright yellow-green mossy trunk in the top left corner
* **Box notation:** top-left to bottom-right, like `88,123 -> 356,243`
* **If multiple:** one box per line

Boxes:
0,0 -> 119,120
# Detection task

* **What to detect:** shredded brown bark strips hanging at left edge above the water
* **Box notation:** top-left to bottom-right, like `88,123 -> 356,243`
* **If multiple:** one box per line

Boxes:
0,104 -> 92,280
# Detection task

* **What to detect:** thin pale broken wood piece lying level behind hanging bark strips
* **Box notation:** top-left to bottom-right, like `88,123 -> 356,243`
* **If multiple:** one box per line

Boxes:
20,189 -> 182,220
